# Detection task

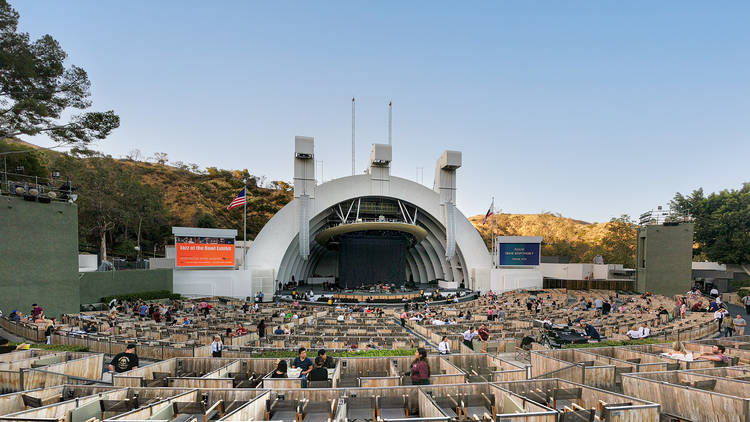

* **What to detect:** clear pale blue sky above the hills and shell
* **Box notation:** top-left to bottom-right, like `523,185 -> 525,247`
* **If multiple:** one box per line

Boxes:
12,1 -> 750,221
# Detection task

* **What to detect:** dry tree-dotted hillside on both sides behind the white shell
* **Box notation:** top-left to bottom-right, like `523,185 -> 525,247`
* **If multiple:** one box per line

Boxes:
0,140 -> 635,265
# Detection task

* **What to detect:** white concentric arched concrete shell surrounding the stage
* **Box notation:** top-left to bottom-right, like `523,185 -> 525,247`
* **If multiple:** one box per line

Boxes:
247,174 -> 492,288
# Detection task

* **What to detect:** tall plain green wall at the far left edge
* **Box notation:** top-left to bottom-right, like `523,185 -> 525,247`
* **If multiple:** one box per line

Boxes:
0,196 -> 79,316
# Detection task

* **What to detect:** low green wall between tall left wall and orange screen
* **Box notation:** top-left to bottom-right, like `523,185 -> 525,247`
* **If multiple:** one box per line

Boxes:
80,269 -> 172,303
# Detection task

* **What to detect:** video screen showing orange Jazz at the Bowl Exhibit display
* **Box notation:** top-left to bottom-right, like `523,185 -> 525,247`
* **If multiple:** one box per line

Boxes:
175,236 -> 234,267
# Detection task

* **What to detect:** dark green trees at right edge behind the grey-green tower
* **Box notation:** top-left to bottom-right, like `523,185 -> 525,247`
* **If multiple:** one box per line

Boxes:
672,183 -> 750,264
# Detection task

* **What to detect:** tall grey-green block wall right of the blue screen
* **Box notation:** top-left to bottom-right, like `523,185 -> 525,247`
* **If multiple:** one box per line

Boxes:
636,223 -> 694,296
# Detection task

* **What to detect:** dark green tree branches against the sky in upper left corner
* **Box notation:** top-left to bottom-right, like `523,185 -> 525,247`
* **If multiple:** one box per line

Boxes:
0,0 -> 120,146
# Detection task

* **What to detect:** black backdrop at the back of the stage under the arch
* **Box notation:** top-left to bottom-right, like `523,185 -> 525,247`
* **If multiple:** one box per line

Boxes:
339,234 -> 406,289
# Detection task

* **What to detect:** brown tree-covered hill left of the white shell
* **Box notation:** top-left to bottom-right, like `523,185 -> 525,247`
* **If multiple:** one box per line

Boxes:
0,140 -> 292,258
